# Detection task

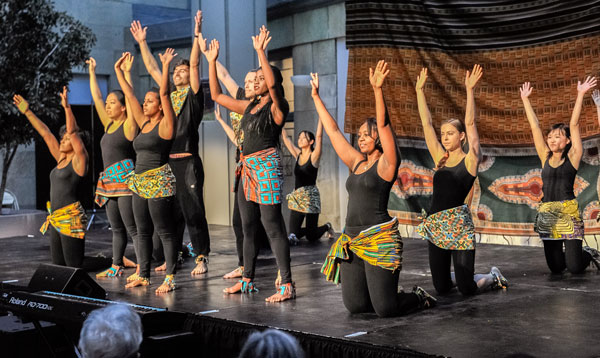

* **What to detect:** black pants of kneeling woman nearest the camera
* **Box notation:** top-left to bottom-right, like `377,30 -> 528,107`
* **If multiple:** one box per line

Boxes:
340,251 -> 419,317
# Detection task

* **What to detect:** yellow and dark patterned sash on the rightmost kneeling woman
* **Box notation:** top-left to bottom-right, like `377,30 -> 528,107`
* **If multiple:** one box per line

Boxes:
533,199 -> 584,240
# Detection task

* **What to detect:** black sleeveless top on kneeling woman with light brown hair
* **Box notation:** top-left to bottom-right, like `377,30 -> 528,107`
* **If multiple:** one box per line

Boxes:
427,158 -> 476,215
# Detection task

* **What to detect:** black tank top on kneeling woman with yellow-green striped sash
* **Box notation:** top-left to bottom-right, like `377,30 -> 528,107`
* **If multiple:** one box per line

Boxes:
346,159 -> 395,227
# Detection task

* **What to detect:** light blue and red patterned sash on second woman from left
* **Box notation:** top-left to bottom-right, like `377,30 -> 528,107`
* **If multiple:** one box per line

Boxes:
94,159 -> 134,207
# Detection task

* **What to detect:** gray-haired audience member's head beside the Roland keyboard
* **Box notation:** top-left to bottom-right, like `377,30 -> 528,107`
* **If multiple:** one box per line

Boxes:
79,304 -> 142,358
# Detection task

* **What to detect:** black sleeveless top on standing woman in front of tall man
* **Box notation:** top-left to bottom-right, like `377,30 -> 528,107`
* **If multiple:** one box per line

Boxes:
133,121 -> 172,174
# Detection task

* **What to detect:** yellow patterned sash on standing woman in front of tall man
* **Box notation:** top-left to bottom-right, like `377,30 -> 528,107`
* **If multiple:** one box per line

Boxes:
127,164 -> 175,199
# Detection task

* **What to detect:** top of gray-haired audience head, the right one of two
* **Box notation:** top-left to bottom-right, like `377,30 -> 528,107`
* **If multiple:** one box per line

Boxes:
239,329 -> 304,358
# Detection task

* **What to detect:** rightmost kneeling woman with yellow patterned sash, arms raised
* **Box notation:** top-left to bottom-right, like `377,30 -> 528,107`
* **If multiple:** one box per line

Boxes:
520,77 -> 600,274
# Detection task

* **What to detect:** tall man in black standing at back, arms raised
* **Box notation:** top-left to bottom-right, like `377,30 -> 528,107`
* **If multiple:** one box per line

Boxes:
131,11 -> 210,275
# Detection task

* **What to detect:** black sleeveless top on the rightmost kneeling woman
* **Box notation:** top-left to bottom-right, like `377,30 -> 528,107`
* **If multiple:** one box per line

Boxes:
542,157 -> 577,203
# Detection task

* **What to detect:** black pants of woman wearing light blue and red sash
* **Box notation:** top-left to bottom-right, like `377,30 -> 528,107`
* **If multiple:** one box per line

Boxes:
106,194 -> 138,266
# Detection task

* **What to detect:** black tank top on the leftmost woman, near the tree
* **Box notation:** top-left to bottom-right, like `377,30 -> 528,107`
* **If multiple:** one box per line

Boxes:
50,160 -> 83,211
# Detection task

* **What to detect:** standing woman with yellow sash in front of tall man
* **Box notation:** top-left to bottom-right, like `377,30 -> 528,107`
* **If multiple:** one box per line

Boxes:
115,48 -> 177,293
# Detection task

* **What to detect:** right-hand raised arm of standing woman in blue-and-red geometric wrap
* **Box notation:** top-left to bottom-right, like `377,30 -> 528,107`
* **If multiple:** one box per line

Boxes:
252,25 -> 285,126
